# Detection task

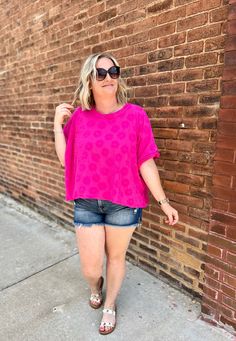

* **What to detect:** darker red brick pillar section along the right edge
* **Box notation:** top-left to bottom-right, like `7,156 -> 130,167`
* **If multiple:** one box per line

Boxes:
202,1 -> 236,329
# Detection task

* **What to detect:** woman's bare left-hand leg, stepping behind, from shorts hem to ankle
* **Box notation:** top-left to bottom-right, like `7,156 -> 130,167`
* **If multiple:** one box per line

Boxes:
76,225 -> 105,294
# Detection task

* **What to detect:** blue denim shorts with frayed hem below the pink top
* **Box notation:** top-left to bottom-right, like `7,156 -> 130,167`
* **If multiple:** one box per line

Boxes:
74,198 -> 142,228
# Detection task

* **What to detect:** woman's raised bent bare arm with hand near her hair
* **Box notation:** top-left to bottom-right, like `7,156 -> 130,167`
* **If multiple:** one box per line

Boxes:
54,103 -> 73,167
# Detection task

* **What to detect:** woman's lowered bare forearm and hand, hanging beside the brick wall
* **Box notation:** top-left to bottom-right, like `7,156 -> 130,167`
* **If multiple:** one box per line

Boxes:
140,159 -> 179,225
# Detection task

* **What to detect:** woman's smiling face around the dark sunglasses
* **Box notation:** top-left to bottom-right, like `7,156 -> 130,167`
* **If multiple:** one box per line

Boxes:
91,57 -> 118,101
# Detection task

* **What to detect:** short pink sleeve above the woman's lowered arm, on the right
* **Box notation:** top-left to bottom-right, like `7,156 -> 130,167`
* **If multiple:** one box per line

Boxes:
137,111 -> 160,168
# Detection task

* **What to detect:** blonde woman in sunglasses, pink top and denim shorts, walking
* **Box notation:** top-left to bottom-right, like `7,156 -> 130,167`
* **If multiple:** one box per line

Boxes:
54,53 -> 178,334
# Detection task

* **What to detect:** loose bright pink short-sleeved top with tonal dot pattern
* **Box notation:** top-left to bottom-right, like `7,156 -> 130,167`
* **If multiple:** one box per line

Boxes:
63,103 -> 160,208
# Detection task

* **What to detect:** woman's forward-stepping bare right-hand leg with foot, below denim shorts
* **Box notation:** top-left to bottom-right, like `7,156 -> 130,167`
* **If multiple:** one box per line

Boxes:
101,226 -> 135,330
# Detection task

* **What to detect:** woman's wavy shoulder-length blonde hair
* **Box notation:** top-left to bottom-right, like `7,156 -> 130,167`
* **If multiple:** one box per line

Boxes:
72,53 -> 127,110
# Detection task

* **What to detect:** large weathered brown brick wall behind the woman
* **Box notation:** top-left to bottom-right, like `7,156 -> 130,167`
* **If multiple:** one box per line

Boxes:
0,0 -> 232,330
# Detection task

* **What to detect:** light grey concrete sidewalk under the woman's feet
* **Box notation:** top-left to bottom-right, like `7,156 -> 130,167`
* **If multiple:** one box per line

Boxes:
0,195 -> 235,341
